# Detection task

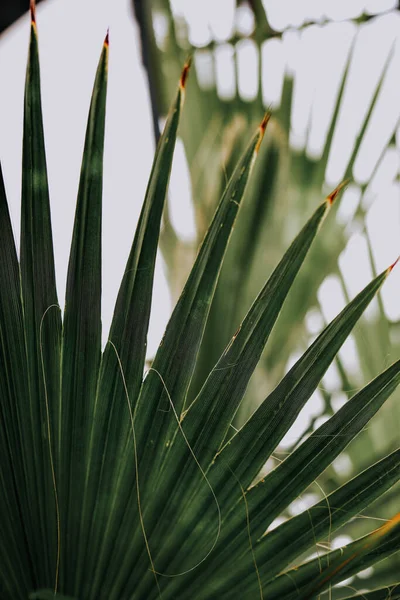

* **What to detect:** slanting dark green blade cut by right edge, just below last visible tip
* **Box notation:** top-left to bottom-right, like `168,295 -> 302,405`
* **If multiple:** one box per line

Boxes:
162,352 -> 400,593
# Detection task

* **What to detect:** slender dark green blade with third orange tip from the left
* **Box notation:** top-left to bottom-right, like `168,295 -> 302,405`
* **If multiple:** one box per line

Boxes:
77,63 -> 189,593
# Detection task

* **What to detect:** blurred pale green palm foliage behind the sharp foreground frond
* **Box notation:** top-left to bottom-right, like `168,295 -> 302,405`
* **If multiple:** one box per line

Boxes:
135,0 -> 400,587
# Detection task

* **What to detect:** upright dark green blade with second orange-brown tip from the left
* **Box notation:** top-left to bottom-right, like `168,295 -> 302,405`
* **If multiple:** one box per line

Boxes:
57,35 -> 108,584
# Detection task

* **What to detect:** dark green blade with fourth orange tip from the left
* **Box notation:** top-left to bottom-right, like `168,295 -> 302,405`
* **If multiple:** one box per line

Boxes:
100,115 -> 269,594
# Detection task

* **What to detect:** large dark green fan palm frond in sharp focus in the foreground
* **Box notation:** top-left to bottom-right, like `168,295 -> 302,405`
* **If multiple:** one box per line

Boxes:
0,6 -> 400,600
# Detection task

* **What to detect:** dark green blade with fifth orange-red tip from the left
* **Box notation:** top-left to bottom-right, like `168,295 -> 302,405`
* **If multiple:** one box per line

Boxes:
143,186 -> 341,592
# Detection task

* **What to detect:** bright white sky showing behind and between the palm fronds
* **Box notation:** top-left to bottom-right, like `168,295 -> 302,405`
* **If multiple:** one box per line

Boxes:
0,0 -> 400,384
